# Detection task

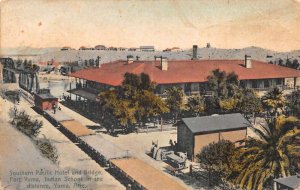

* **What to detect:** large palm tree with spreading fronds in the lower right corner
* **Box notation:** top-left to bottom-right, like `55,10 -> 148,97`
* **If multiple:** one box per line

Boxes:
234,115 -> 300,190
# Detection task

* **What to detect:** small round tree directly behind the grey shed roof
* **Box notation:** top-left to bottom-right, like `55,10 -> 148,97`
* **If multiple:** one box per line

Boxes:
186,95 -> 205,116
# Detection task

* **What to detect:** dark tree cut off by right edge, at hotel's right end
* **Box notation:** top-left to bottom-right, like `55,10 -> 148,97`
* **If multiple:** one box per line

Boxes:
286,90 -> 300,118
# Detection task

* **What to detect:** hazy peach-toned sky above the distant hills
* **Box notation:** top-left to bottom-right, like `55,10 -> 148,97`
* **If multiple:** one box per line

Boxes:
0,0 -> 300,51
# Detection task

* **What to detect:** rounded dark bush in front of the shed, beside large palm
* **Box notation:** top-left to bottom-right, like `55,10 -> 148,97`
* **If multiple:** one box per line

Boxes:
196,140 -> 239,184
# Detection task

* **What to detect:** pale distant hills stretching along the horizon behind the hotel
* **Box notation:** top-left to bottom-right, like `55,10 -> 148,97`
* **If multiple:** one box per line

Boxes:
1,46 -> 300,63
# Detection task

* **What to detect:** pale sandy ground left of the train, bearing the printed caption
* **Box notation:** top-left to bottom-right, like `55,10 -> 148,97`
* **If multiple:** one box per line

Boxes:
0,98 -> 125,190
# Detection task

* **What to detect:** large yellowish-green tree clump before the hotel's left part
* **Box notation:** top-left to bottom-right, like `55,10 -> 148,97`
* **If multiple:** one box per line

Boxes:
99,73 -> 169,130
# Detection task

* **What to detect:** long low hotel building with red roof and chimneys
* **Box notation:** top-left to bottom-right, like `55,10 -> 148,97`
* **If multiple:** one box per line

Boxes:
70,56 -> 300,101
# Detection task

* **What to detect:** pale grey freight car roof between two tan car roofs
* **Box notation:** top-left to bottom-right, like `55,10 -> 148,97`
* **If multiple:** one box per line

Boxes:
80,135 -> 130,160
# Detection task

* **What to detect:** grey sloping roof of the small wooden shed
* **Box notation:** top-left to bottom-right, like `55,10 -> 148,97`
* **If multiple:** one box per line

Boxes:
182,113 -> 250,133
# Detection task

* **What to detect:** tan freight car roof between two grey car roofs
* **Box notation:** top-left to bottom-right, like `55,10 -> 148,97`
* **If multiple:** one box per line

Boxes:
61,120 -> 95,137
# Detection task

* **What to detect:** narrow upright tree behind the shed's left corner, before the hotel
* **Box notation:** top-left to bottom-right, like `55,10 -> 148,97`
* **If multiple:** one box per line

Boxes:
165,87 -> 184,123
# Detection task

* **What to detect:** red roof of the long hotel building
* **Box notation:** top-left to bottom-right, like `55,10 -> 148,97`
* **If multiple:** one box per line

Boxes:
71,60 -> 300,86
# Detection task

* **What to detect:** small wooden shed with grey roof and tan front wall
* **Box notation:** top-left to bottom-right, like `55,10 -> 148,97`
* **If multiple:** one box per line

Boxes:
177,113 -> 250,160
